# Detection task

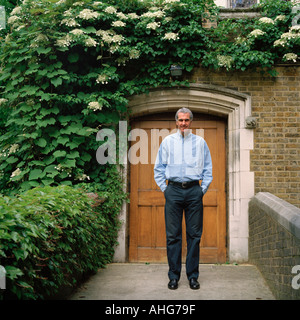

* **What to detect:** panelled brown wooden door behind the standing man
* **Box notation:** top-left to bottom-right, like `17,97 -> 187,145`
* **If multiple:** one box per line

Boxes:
129,115 -> 226,263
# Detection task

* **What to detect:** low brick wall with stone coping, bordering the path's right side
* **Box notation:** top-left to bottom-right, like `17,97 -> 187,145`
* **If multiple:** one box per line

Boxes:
249,193 -> 300,300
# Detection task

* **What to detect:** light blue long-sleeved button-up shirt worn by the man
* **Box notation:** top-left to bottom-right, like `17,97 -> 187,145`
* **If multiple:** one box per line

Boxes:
154,131 -> 213,194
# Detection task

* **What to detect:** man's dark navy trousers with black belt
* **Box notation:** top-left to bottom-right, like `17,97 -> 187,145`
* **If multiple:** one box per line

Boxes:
165,184 -> 203,280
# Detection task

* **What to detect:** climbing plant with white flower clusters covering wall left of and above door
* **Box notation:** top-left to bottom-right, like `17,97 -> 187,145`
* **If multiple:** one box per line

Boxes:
0,0 -> 299,193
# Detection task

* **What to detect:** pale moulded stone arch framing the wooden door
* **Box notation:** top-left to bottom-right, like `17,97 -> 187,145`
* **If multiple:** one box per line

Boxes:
116,84 -> 255,262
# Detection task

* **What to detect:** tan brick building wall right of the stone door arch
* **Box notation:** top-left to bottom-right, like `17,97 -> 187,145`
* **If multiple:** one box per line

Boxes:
189,66 -> 300,207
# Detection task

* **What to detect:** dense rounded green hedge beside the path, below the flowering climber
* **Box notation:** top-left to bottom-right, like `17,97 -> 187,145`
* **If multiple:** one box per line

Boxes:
0,186 -> 119,300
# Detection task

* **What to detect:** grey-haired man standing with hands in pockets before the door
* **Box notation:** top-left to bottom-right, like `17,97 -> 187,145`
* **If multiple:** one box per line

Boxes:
154,108 -> 212,290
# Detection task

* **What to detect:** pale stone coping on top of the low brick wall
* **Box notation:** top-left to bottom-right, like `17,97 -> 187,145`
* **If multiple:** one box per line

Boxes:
250,192 -> 300,239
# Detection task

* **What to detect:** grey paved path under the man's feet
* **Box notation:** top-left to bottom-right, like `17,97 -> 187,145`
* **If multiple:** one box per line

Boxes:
69,263 -> 275,300
